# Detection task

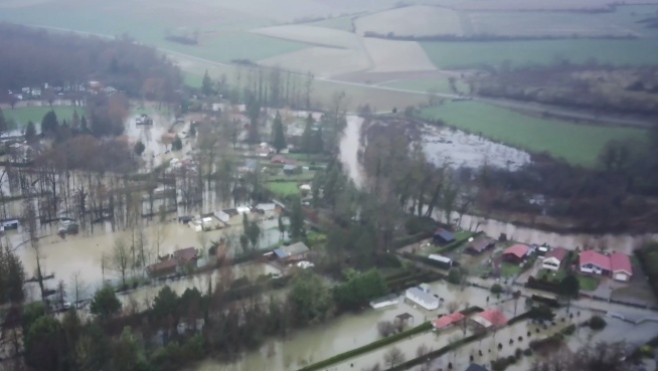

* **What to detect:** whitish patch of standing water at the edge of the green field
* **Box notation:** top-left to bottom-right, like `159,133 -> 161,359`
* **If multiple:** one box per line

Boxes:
421,125 -> 531,171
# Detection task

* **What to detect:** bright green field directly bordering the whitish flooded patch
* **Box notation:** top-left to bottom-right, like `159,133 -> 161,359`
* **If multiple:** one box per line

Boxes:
421,101 -> 647,167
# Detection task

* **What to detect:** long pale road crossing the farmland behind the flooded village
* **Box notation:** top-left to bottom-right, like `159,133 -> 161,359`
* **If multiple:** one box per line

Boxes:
25,25 -> 653,128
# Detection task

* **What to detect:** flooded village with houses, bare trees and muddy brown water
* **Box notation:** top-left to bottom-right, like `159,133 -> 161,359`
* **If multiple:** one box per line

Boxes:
0,25 -> 658,371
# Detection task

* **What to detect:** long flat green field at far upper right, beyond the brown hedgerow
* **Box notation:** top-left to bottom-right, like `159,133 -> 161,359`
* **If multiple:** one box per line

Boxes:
421,39 -> 658,68
